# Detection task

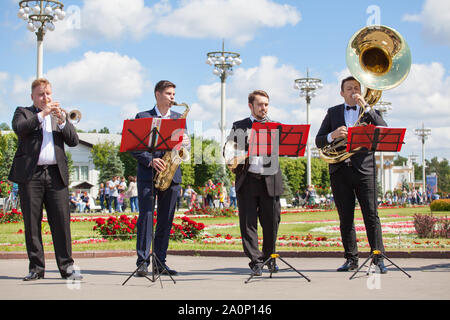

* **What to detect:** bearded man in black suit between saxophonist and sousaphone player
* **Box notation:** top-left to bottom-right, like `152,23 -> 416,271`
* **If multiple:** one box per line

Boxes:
227,90 -> 283,275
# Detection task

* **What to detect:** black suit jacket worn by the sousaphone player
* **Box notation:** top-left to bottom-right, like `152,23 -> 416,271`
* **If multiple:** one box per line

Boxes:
316,104 -> 387,175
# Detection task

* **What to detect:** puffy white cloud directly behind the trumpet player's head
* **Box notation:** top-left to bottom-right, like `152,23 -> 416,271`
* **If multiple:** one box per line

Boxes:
13,51 -> 147,107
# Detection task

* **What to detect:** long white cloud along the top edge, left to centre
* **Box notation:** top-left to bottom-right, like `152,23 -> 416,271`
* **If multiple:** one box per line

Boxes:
22,0 -> 301,51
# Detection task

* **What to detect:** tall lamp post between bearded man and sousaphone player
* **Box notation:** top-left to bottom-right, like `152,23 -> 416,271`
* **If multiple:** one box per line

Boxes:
294,70 -> 323,186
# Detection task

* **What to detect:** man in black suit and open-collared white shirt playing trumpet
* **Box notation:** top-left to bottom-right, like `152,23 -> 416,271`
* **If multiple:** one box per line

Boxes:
8,79 -> 81,281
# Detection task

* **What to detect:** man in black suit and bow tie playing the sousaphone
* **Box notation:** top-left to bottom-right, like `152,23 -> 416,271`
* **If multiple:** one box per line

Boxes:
316,77 -> 387,273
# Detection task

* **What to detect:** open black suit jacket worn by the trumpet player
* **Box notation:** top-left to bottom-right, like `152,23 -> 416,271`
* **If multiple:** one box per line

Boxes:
8,106 -> 79,186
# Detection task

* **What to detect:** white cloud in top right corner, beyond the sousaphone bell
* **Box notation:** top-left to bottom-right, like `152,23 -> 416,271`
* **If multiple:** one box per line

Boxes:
403,0 -> 450,45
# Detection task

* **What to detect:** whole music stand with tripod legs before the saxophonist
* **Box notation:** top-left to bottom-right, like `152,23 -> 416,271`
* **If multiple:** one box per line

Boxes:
119,118 -> 186,287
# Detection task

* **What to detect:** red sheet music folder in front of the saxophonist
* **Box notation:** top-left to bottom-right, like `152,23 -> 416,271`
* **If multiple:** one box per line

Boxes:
120,118 -> 186,152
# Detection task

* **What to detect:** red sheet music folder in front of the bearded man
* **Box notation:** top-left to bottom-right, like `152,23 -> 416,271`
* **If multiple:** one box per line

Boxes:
248,121 -> 311,157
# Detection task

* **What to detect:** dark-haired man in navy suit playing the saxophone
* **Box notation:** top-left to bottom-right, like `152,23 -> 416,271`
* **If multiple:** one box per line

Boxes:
132,80 -> 190,277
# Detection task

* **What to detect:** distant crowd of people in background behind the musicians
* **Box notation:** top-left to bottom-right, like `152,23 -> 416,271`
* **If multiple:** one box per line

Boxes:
64,176 -> 446,213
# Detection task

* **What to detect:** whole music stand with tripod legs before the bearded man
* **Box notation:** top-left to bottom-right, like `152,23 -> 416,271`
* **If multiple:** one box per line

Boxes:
245,121 -> 311,283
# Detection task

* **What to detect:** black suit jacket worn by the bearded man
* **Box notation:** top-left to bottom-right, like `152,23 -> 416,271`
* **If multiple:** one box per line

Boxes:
227,118 -> 284,197
